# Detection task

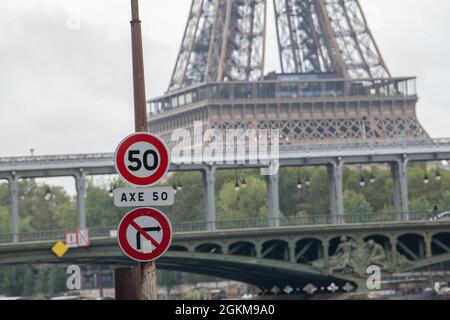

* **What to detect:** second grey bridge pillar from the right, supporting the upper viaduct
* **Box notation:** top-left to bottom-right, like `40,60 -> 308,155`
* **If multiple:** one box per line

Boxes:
328,159 -> 345,224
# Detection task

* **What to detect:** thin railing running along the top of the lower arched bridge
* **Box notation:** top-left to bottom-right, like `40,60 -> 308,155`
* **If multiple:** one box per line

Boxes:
0,212 -> 440,243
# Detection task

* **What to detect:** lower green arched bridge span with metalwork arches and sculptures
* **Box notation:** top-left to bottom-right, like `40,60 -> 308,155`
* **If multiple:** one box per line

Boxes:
0,214 -> 450,290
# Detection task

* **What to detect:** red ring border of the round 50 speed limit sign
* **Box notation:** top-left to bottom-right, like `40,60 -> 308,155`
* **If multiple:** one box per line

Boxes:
115,132 -> 169,186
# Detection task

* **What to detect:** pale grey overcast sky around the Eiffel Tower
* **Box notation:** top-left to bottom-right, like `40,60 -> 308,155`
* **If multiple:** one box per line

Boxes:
0,0 -> 450,160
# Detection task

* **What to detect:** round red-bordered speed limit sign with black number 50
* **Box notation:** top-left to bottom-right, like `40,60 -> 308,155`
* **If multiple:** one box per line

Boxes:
114,132 -> 169,186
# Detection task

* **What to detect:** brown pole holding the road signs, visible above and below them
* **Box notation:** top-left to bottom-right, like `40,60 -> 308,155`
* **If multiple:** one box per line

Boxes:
130,0 -> 158,300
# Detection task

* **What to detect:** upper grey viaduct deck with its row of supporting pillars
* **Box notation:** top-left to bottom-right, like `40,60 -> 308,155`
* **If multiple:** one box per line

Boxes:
0,139 -> 450,241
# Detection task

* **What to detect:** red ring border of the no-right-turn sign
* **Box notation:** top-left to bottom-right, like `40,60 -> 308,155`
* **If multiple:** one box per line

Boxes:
117,208 -> 172,262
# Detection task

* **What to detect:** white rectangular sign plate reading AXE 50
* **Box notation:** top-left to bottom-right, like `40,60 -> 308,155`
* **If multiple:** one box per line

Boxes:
113,187 -> 175,208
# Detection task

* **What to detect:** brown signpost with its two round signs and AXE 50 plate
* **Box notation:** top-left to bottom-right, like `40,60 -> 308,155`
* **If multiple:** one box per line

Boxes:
114,0 -> 174,300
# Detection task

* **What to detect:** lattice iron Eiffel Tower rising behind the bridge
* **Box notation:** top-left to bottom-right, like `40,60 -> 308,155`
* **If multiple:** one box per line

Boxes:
149,0 -> 428,144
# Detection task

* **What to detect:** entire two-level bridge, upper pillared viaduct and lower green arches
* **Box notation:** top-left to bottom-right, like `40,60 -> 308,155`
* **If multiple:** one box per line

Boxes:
0,139 -> 450,289
